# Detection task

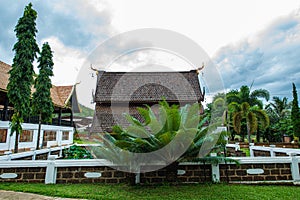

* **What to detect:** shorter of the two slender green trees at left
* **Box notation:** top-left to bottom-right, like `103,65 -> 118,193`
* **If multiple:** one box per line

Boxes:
32,43 -> 54,149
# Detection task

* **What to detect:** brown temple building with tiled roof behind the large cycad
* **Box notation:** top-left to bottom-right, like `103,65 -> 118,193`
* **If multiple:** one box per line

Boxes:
91,70 -> 204,133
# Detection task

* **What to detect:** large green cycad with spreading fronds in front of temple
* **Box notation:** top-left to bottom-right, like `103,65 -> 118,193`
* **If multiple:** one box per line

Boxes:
92,101 -> 229,173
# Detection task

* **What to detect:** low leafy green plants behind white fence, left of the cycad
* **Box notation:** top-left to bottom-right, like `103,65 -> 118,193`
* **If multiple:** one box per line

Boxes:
63,145 -> 93,159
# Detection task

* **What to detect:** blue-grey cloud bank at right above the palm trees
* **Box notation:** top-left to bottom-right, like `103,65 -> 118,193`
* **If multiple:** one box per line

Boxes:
214,9 -> 300,97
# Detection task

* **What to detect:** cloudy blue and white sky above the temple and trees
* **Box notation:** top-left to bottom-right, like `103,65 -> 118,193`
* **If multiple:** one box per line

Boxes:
0,0 -> 300,106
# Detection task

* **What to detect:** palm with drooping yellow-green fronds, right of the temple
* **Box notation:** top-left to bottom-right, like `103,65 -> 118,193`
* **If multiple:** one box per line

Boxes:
229,102 -> 270,142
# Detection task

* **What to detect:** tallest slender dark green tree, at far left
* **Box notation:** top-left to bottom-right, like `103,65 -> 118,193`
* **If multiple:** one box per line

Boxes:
7,3 -> 39,153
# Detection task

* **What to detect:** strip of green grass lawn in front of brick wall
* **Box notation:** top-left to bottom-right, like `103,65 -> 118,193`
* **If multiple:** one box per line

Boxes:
0,183 -> 300,200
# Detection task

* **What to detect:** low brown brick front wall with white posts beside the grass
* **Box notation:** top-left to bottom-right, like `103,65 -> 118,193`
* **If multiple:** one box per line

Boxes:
0,155 -> 300,184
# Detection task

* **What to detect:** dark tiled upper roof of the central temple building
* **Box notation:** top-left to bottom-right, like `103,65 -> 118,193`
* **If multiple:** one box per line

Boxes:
95,70 -> 204,103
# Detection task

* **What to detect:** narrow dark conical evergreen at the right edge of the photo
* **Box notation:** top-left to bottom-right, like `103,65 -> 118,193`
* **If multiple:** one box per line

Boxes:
291,83 -> 300,137
